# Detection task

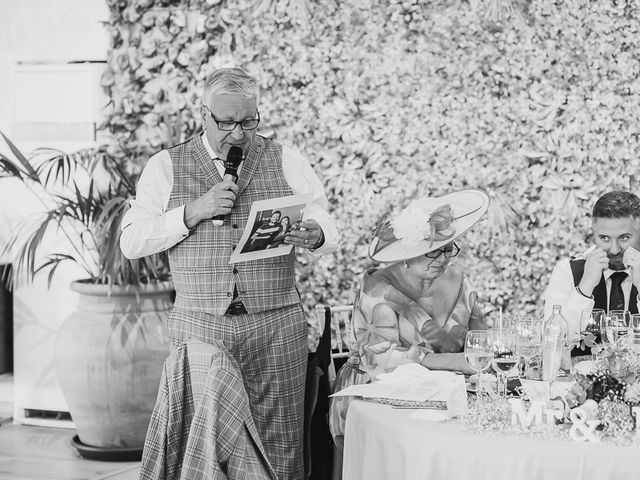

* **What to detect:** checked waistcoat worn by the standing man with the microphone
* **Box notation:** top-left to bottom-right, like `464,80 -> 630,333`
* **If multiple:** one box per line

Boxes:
168,135 -> 300,321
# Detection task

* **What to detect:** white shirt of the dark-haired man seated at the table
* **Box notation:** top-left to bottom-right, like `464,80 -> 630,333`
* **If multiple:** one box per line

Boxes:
543,258 -> 638,338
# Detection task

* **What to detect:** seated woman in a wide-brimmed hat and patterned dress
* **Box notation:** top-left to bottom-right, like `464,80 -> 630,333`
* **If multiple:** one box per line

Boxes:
353,190 -> 489,377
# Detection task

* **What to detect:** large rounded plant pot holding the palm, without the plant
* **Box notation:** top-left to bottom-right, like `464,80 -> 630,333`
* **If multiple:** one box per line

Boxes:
55,281 -> 173,449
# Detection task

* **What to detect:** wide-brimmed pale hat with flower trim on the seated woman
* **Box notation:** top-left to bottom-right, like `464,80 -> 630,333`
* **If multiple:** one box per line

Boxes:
369,189 -> 489,262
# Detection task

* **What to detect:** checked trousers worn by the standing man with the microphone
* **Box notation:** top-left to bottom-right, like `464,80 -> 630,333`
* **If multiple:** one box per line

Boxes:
168,304 -> 308,480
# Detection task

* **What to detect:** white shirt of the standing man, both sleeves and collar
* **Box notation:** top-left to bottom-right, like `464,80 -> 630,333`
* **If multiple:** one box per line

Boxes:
120,134 -> 339,259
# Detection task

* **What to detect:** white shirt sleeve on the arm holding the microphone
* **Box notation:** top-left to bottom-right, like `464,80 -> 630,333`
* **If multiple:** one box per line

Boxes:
120,150 -> 189,259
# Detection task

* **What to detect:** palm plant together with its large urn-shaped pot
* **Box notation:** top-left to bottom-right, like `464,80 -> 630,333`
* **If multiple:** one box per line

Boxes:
0,132 -> 173,454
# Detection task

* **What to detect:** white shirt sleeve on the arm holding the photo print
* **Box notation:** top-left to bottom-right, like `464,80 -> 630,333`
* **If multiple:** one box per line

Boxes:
282,146 -> 340,255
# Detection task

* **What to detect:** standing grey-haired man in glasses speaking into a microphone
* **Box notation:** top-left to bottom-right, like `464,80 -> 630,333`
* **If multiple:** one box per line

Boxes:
120,68 -> 338,479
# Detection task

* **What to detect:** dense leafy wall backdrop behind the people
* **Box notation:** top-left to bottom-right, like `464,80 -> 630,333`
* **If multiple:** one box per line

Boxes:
103,0 -> 640,344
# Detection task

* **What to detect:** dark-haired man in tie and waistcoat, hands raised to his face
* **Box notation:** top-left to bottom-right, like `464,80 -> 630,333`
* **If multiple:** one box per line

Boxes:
544,191 -> 640,339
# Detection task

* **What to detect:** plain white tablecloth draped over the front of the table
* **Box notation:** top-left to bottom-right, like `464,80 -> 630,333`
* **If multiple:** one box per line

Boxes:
343,400 -> 640,480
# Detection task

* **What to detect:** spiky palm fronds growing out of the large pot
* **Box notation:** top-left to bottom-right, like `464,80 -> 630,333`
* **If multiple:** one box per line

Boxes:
0,132 -> 169,285
